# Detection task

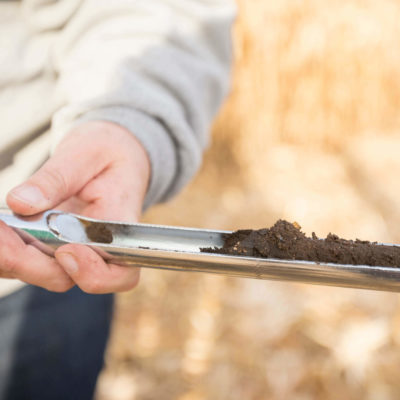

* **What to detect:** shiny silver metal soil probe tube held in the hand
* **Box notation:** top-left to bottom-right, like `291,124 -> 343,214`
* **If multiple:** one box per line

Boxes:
0,209 -> 400,292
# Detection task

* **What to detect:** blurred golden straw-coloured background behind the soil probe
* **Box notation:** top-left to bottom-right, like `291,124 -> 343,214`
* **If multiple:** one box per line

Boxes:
97,0 -> 400,400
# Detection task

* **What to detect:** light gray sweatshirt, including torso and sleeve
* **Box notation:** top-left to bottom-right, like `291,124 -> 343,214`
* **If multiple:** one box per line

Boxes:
0,0 -> 235,211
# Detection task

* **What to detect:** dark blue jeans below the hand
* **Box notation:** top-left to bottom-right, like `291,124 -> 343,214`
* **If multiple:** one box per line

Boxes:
0,286 -> 113,400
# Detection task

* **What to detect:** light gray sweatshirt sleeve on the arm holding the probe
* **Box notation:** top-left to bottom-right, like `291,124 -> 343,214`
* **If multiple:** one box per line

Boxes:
45,0 -> 235,207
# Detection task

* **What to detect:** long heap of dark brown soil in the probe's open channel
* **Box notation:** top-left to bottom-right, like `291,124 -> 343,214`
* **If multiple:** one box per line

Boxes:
201,220 -> 400,267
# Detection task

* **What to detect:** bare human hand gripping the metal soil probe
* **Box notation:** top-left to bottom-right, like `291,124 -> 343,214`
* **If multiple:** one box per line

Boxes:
0,121 -> 150,293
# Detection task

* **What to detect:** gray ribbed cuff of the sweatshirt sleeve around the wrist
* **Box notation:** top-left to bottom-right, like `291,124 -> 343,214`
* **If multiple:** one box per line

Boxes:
53,106 -> 178,209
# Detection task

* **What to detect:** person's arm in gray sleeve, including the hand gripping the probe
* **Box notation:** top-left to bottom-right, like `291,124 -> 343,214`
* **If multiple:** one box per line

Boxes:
0,0 -> 233,293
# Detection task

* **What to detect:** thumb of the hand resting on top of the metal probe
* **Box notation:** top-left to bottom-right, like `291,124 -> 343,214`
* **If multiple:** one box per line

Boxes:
7,141 -> 106,215
